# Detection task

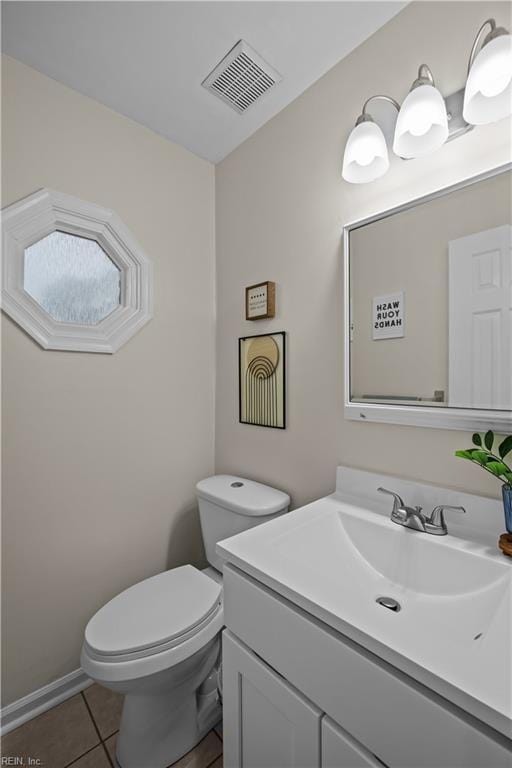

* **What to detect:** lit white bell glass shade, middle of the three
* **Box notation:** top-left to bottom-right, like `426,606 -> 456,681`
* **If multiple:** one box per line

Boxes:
393,85 -> 448,158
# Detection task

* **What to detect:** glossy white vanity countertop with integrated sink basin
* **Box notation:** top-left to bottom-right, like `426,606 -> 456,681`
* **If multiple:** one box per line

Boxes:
218,486 -> 512,731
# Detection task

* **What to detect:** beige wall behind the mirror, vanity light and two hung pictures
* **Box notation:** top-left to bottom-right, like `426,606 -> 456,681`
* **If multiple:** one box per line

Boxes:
216,2 -> 511,504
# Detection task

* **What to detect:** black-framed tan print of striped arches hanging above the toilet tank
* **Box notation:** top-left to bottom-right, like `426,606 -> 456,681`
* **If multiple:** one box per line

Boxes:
238,331 -> 286,429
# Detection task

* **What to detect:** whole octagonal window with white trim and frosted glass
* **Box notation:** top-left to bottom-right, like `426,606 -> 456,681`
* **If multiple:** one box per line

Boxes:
0,188 -> 153,354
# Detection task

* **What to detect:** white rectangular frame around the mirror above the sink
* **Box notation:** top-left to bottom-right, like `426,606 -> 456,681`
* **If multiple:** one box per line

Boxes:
343,163 -> 512,433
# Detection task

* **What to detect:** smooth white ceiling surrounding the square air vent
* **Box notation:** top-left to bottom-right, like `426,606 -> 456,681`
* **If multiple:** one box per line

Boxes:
2,0 -> 406,162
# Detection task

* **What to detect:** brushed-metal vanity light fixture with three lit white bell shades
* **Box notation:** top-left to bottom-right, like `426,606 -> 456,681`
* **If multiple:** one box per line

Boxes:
342,19 -> 512,184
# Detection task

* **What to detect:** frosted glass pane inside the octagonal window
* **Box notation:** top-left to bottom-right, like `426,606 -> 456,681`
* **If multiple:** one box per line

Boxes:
23,232 -> 121,325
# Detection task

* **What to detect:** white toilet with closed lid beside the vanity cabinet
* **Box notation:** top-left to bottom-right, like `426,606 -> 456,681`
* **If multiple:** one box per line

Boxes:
81,475 -> 290,768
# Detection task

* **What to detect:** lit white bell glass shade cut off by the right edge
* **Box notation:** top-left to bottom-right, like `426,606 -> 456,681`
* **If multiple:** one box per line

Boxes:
462,35 -> 512,125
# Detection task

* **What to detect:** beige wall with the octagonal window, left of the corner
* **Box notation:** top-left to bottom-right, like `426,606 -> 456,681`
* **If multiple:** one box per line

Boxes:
2,52 -> 215,704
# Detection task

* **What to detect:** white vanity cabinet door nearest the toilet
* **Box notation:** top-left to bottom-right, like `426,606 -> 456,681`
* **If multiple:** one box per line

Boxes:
222,630 -> 322,768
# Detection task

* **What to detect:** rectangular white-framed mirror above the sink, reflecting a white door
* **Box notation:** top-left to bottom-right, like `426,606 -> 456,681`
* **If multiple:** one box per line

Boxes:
344,165 -> 512,431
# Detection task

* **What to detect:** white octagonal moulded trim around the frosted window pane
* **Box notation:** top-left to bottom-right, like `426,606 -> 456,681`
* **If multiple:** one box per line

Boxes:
2,189 -> 153,353
